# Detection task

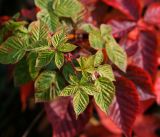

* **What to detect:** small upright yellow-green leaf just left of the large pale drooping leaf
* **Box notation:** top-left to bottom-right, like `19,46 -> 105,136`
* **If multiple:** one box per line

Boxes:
94,50 -> 104,67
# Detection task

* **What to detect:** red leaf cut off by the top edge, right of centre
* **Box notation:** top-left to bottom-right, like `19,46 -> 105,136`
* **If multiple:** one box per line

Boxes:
103,0 -> 141,20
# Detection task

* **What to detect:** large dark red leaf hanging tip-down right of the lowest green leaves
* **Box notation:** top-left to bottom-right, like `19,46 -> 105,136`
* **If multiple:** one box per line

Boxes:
109,77 -> 139,137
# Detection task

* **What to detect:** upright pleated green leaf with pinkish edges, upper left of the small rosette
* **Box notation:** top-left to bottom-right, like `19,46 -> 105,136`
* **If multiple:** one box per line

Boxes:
28,20 -> 49,43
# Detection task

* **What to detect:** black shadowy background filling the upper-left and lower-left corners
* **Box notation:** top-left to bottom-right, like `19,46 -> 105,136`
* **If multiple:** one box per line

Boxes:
0,0 -> 52,137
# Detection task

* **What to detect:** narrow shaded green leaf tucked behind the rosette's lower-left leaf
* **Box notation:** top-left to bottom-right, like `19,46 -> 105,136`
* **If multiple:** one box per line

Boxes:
27,52 -> 40,80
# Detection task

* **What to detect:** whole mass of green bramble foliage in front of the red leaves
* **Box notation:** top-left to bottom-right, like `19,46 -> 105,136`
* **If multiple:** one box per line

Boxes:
0,0 -> 127,116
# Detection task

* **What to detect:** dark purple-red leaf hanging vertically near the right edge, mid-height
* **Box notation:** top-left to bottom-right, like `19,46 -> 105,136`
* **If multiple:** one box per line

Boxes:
133,31 -> 157,79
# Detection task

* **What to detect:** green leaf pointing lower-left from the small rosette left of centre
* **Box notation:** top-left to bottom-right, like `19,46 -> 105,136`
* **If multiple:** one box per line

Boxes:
35,50 -> 54,68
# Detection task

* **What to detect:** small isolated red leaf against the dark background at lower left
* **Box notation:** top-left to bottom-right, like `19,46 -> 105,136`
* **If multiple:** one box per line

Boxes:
20,81 -> 34,110
